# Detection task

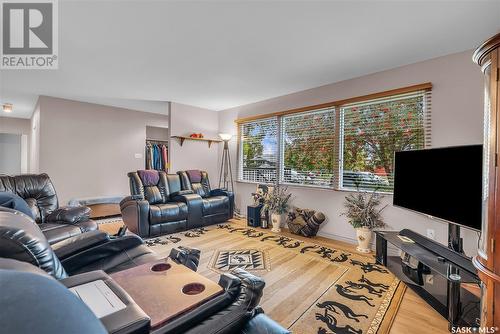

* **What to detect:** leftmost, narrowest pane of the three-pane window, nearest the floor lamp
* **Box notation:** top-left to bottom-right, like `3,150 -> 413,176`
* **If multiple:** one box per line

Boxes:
238,117 -> 278,183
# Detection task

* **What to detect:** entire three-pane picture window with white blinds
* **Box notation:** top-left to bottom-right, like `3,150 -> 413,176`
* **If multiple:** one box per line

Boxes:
238,84 -> 431,192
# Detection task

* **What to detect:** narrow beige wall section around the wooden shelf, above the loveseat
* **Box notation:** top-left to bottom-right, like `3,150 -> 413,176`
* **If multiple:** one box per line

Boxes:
170,102 -> 222,187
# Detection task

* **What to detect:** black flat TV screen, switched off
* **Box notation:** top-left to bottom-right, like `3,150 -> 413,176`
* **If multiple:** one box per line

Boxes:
393,145 -> 483,230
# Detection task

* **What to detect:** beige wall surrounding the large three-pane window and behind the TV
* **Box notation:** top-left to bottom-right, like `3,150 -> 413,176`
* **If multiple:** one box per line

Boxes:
219,51 -> 483,254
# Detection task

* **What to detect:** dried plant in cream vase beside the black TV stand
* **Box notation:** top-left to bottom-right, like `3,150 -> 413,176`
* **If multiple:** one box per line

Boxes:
341,190 -> 387,253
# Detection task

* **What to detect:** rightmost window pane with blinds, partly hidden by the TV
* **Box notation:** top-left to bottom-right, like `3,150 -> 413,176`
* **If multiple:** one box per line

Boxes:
340,92 -> 430,192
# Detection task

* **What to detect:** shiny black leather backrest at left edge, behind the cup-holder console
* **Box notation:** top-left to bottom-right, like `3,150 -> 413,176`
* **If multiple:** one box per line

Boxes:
0,207 -> 68,279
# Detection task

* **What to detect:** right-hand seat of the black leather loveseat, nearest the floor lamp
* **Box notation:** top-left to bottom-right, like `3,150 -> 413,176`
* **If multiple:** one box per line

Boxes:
177,170 -> 234,226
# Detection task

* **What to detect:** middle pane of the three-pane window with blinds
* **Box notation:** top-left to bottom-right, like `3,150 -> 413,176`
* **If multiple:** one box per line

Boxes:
280,108 -> 335,187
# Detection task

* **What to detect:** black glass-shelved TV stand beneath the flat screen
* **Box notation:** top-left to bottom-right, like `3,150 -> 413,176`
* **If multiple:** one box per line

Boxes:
375,229 -> 480,331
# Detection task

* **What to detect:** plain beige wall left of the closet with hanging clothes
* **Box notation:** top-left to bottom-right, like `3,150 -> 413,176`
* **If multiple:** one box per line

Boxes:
38,96 -> 168,204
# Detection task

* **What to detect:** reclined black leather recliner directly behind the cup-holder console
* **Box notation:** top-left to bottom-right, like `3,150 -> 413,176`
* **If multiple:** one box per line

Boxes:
0,207 -> 159,279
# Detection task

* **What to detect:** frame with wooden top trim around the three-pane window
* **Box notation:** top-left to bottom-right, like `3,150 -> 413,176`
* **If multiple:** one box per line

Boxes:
235,83 -> 432,194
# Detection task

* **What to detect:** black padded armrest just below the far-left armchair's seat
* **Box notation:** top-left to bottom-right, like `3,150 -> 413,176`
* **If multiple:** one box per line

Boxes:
52,231 -> 109,261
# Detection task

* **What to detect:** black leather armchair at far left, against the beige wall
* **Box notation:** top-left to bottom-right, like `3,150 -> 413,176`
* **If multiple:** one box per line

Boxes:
0,174 -> 97,244
